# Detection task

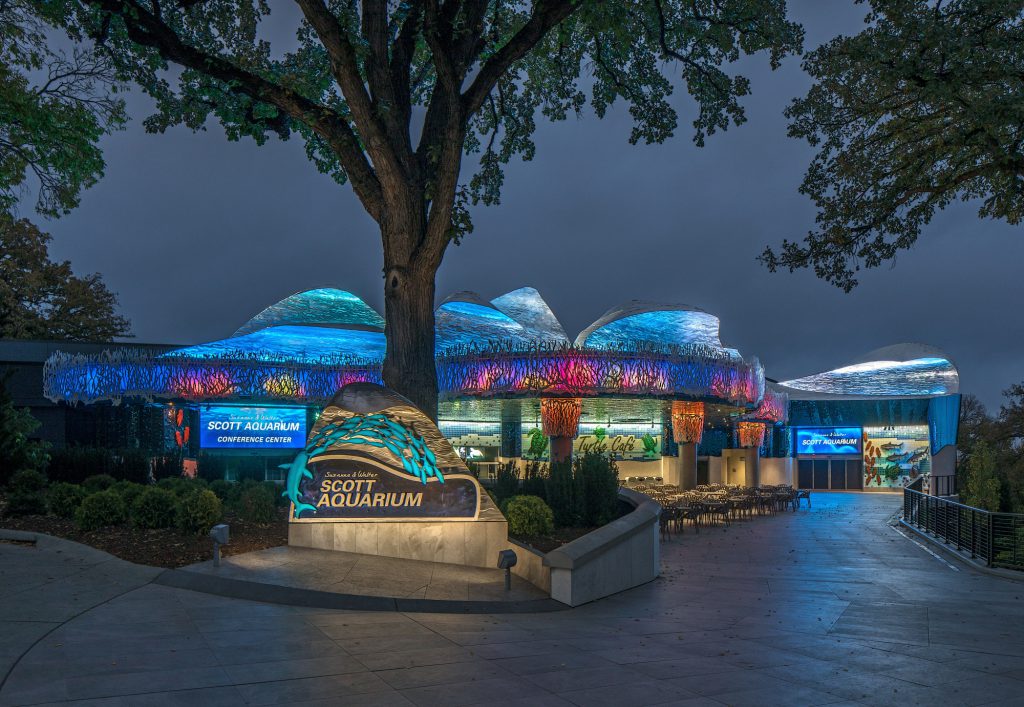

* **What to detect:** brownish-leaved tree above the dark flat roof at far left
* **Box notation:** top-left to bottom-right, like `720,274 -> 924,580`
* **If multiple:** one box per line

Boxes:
0,212 -> 130,341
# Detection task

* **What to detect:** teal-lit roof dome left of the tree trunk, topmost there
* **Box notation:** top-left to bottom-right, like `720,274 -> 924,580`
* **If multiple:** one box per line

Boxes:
234,288 -> 384,336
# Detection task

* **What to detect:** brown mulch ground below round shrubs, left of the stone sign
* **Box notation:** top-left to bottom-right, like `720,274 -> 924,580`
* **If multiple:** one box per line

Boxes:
0,508 -> 288,568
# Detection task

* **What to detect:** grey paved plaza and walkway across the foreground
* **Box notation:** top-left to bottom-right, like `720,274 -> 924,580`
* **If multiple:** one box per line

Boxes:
0,494 -> 1024,707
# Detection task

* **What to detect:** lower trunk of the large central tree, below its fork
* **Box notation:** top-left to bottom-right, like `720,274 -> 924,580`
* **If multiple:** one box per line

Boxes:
384,256 -> 437,420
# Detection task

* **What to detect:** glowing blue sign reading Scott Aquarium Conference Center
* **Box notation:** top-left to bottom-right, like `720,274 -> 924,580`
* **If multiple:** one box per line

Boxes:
199,405 -> 306,449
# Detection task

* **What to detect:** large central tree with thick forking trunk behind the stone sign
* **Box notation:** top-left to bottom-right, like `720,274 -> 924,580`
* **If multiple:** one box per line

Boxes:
48,0 -> 802,415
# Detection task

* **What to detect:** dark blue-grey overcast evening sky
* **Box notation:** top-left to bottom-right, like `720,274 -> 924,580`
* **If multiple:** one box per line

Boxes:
36,0 -> 1024,408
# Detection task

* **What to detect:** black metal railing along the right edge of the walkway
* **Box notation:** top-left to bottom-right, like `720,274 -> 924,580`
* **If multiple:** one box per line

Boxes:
903,489 -> 1024,570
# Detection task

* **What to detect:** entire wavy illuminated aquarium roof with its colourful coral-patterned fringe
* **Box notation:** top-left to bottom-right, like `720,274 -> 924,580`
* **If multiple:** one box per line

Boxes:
37,288 -> 958,409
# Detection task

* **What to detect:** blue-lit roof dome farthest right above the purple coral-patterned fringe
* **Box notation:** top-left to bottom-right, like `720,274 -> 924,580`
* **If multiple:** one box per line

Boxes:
575,300 -> 722,348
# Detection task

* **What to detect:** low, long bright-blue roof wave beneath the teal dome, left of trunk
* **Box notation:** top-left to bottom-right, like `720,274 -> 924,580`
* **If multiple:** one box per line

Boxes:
161,326 -> 386,363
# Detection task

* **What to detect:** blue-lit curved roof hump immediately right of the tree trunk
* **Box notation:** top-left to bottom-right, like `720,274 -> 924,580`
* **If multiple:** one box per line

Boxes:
434,293 -> 537,351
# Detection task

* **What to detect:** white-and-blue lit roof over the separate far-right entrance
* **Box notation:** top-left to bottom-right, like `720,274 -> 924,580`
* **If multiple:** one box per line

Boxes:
780,343 -> 959,399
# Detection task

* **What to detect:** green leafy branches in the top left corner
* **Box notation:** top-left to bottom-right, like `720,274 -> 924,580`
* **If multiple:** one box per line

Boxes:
0,0 -> 125,216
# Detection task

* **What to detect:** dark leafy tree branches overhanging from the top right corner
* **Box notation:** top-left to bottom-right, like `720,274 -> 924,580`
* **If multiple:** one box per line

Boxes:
761,0 -> 1024,291
